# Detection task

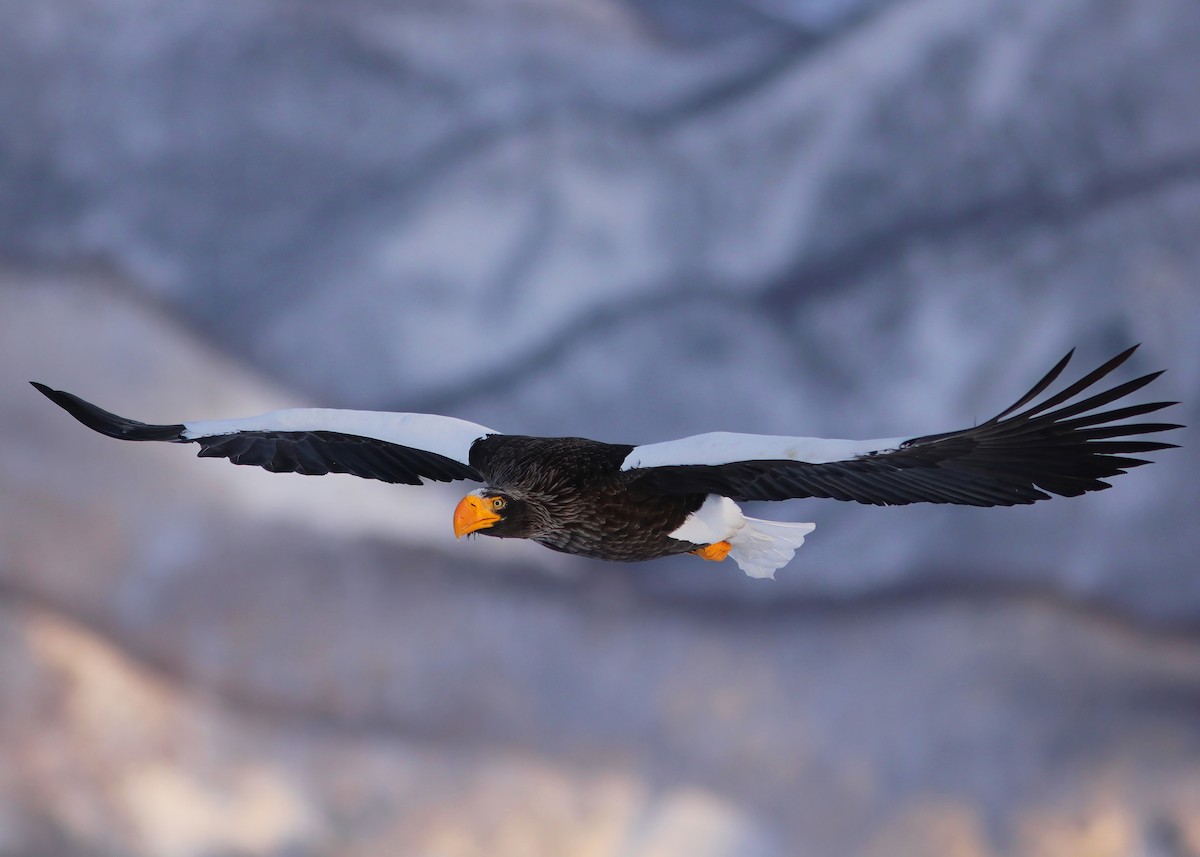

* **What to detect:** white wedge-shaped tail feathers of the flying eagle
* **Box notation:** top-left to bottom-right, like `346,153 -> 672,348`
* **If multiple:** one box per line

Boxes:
670,495 -> 816,579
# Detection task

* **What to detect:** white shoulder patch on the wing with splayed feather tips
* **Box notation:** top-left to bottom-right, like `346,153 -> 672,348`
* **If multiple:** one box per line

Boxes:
620,431 -> 906,471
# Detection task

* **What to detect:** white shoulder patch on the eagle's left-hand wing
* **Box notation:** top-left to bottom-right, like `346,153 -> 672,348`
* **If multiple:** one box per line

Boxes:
184,408 -> 498,465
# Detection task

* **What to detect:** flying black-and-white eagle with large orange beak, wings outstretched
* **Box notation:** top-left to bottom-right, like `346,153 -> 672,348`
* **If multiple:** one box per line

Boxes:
31,346 -> 1183,577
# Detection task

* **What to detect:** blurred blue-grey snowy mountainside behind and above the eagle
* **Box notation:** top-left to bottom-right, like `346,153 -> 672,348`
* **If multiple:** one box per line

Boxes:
0,0 -> 1200,613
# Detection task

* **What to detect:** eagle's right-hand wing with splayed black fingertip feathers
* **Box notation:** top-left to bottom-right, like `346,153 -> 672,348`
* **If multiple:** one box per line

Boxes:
622,346 -> 1182,505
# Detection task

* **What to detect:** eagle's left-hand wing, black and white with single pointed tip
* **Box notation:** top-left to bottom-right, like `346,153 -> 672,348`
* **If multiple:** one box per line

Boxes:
34,382 -> 497,485
